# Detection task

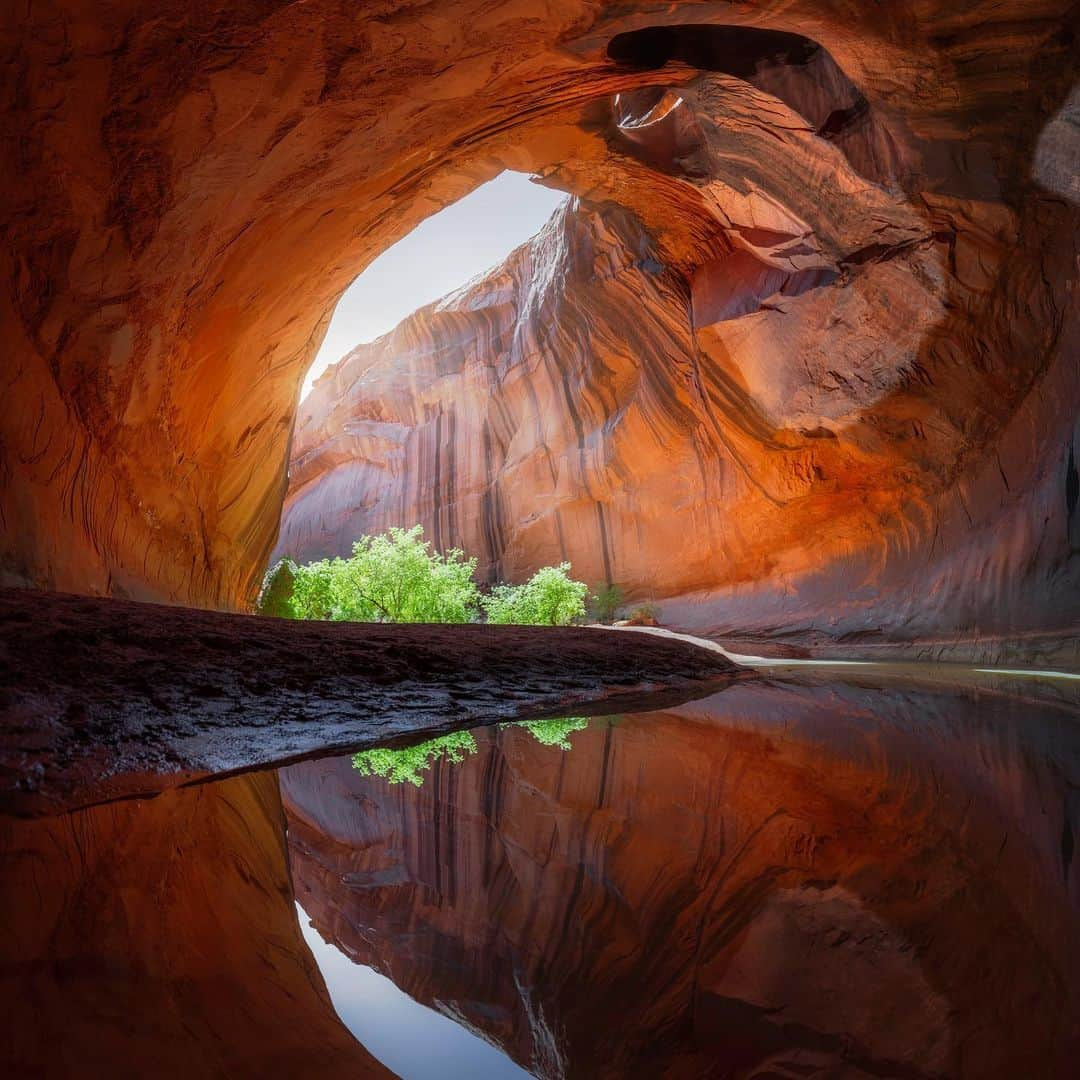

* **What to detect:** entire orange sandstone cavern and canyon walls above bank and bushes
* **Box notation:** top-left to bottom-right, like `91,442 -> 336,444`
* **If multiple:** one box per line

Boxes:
0,0 -> 1080,639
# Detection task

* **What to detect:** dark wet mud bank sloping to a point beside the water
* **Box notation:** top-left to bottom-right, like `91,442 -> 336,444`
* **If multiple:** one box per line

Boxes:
0,590 -> 739,813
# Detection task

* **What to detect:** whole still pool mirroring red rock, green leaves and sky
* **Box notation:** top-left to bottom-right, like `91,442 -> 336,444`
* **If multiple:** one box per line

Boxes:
0,669 -> 1080,1080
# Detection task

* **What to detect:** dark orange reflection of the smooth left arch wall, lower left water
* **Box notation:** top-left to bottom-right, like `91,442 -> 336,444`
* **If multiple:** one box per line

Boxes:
0,773 -> 391,1077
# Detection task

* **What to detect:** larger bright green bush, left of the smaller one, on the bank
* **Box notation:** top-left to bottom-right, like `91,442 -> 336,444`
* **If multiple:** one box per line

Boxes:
292,525 -> 477,622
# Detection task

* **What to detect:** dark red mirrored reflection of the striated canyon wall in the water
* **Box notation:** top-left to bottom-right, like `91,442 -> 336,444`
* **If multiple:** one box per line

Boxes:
281,681 -> 1080,1078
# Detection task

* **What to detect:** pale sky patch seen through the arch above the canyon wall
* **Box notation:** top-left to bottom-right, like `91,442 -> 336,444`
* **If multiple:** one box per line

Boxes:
300,173 -> 566,400
